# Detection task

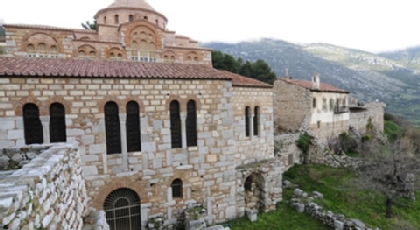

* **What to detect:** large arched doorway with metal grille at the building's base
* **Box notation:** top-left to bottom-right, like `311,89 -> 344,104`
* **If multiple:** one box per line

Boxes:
104,188 -> 141,230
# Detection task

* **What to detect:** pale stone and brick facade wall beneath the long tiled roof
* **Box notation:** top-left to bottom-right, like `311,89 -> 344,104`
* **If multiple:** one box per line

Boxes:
0,78 -> 260,225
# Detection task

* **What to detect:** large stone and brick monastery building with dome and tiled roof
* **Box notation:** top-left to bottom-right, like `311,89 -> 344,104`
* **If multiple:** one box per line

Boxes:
0,0 -> 282,229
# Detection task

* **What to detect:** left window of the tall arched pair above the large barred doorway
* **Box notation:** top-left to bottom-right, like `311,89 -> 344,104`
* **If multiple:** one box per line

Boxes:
105,101 -> 121,154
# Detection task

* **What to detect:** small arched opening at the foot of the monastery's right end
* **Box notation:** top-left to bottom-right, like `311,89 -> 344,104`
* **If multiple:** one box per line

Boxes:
244,173 -> 263,211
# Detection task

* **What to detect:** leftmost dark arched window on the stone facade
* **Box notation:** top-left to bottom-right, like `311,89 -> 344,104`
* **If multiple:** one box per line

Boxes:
22,103 -> 44,145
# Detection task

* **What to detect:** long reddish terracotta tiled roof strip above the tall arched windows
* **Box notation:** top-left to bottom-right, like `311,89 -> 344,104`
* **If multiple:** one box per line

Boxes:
0,57 -> 272,88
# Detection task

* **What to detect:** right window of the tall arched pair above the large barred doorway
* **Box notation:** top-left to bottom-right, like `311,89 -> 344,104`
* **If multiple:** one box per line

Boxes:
126,101 -> 141,152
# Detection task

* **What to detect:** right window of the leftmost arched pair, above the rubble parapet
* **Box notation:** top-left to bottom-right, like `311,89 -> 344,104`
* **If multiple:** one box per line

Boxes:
50,103 -> 66,142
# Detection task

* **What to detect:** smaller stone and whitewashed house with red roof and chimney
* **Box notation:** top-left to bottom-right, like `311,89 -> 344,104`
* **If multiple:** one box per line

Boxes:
274,74 -> 350,142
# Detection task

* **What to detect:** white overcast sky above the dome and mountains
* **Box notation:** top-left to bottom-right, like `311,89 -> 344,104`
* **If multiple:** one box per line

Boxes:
0,0 -> 420,52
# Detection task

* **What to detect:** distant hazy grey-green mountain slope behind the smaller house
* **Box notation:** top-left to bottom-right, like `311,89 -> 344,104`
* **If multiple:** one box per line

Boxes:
202,39 -> 420,125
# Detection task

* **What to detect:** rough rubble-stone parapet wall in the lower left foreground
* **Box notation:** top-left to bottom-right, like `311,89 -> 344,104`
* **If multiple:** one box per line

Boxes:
0,143 -> 105,230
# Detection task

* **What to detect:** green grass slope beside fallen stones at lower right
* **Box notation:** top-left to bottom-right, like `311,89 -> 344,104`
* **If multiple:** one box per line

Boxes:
284,164 -> 420,230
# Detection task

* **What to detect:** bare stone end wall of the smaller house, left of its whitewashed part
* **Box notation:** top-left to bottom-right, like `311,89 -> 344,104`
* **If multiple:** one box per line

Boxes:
274,80 -> 312,134
